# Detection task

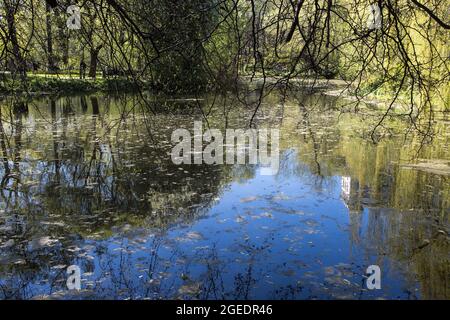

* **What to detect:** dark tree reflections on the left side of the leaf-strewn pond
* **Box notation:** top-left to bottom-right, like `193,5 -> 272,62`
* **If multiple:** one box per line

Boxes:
0,96 -> 256,298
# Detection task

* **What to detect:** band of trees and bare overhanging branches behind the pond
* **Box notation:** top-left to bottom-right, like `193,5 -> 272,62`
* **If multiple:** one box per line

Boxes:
0,0 -> 450,130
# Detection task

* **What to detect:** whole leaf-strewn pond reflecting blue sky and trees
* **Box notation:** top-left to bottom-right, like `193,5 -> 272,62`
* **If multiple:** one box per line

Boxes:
0,92 -> 450,299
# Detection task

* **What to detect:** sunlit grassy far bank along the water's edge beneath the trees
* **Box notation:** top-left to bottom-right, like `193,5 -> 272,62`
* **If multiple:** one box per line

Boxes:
0,75 -> 446,117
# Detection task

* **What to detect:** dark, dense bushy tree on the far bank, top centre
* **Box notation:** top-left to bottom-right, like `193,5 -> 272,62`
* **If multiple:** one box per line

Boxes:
142,0 -> 215,93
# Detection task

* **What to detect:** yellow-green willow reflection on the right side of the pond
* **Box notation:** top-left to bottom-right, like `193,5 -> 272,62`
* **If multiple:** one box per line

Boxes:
280,93 -> 450,298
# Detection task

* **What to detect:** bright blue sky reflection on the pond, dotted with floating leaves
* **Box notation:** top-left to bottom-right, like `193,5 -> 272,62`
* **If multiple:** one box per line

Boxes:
16,152 -> 414,299
